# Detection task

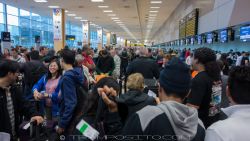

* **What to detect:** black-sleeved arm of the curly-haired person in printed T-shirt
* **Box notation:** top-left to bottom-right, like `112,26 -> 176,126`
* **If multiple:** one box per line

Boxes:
187,78 -> 207,109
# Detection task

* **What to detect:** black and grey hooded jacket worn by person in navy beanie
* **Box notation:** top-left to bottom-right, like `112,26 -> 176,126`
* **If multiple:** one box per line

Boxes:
105,101 -> 205,141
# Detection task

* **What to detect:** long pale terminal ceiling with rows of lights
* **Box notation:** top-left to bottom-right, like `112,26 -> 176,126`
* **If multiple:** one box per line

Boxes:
0,0 -> 182,42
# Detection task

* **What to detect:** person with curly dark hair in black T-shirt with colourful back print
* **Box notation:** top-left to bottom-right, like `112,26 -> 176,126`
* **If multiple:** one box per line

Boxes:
187,47 -> 222,127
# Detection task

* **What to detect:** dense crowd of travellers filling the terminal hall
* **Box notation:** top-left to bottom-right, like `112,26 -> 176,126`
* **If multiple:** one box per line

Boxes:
0,45 -> 250,141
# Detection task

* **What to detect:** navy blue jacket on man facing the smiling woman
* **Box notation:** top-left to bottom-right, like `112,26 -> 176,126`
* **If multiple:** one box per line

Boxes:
59,68 -> 84,129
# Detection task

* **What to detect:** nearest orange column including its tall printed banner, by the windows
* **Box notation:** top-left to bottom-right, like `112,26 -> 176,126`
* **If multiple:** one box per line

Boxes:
53,8 -> 65,52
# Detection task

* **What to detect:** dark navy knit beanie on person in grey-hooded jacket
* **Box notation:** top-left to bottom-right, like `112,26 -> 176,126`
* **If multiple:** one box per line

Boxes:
159,57 -> 191,94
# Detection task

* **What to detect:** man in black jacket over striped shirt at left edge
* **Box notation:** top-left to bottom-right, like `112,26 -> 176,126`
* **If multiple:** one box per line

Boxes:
0,60 -> 43,140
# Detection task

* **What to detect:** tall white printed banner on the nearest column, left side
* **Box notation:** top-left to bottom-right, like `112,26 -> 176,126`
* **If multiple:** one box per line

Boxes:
53,9 -> 62,40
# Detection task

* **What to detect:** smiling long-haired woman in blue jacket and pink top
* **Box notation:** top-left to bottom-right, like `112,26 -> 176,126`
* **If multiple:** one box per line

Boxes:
32,59 -> 62,121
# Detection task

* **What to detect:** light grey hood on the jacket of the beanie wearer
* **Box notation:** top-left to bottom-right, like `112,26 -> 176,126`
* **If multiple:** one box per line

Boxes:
157,101 -> 204,141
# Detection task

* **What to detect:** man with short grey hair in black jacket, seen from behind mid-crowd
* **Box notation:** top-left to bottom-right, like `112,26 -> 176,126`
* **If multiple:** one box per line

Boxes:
126,48 -> 160,79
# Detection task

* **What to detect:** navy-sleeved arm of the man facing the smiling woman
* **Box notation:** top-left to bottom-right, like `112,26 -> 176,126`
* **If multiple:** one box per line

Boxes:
59,78 -> 77,129
